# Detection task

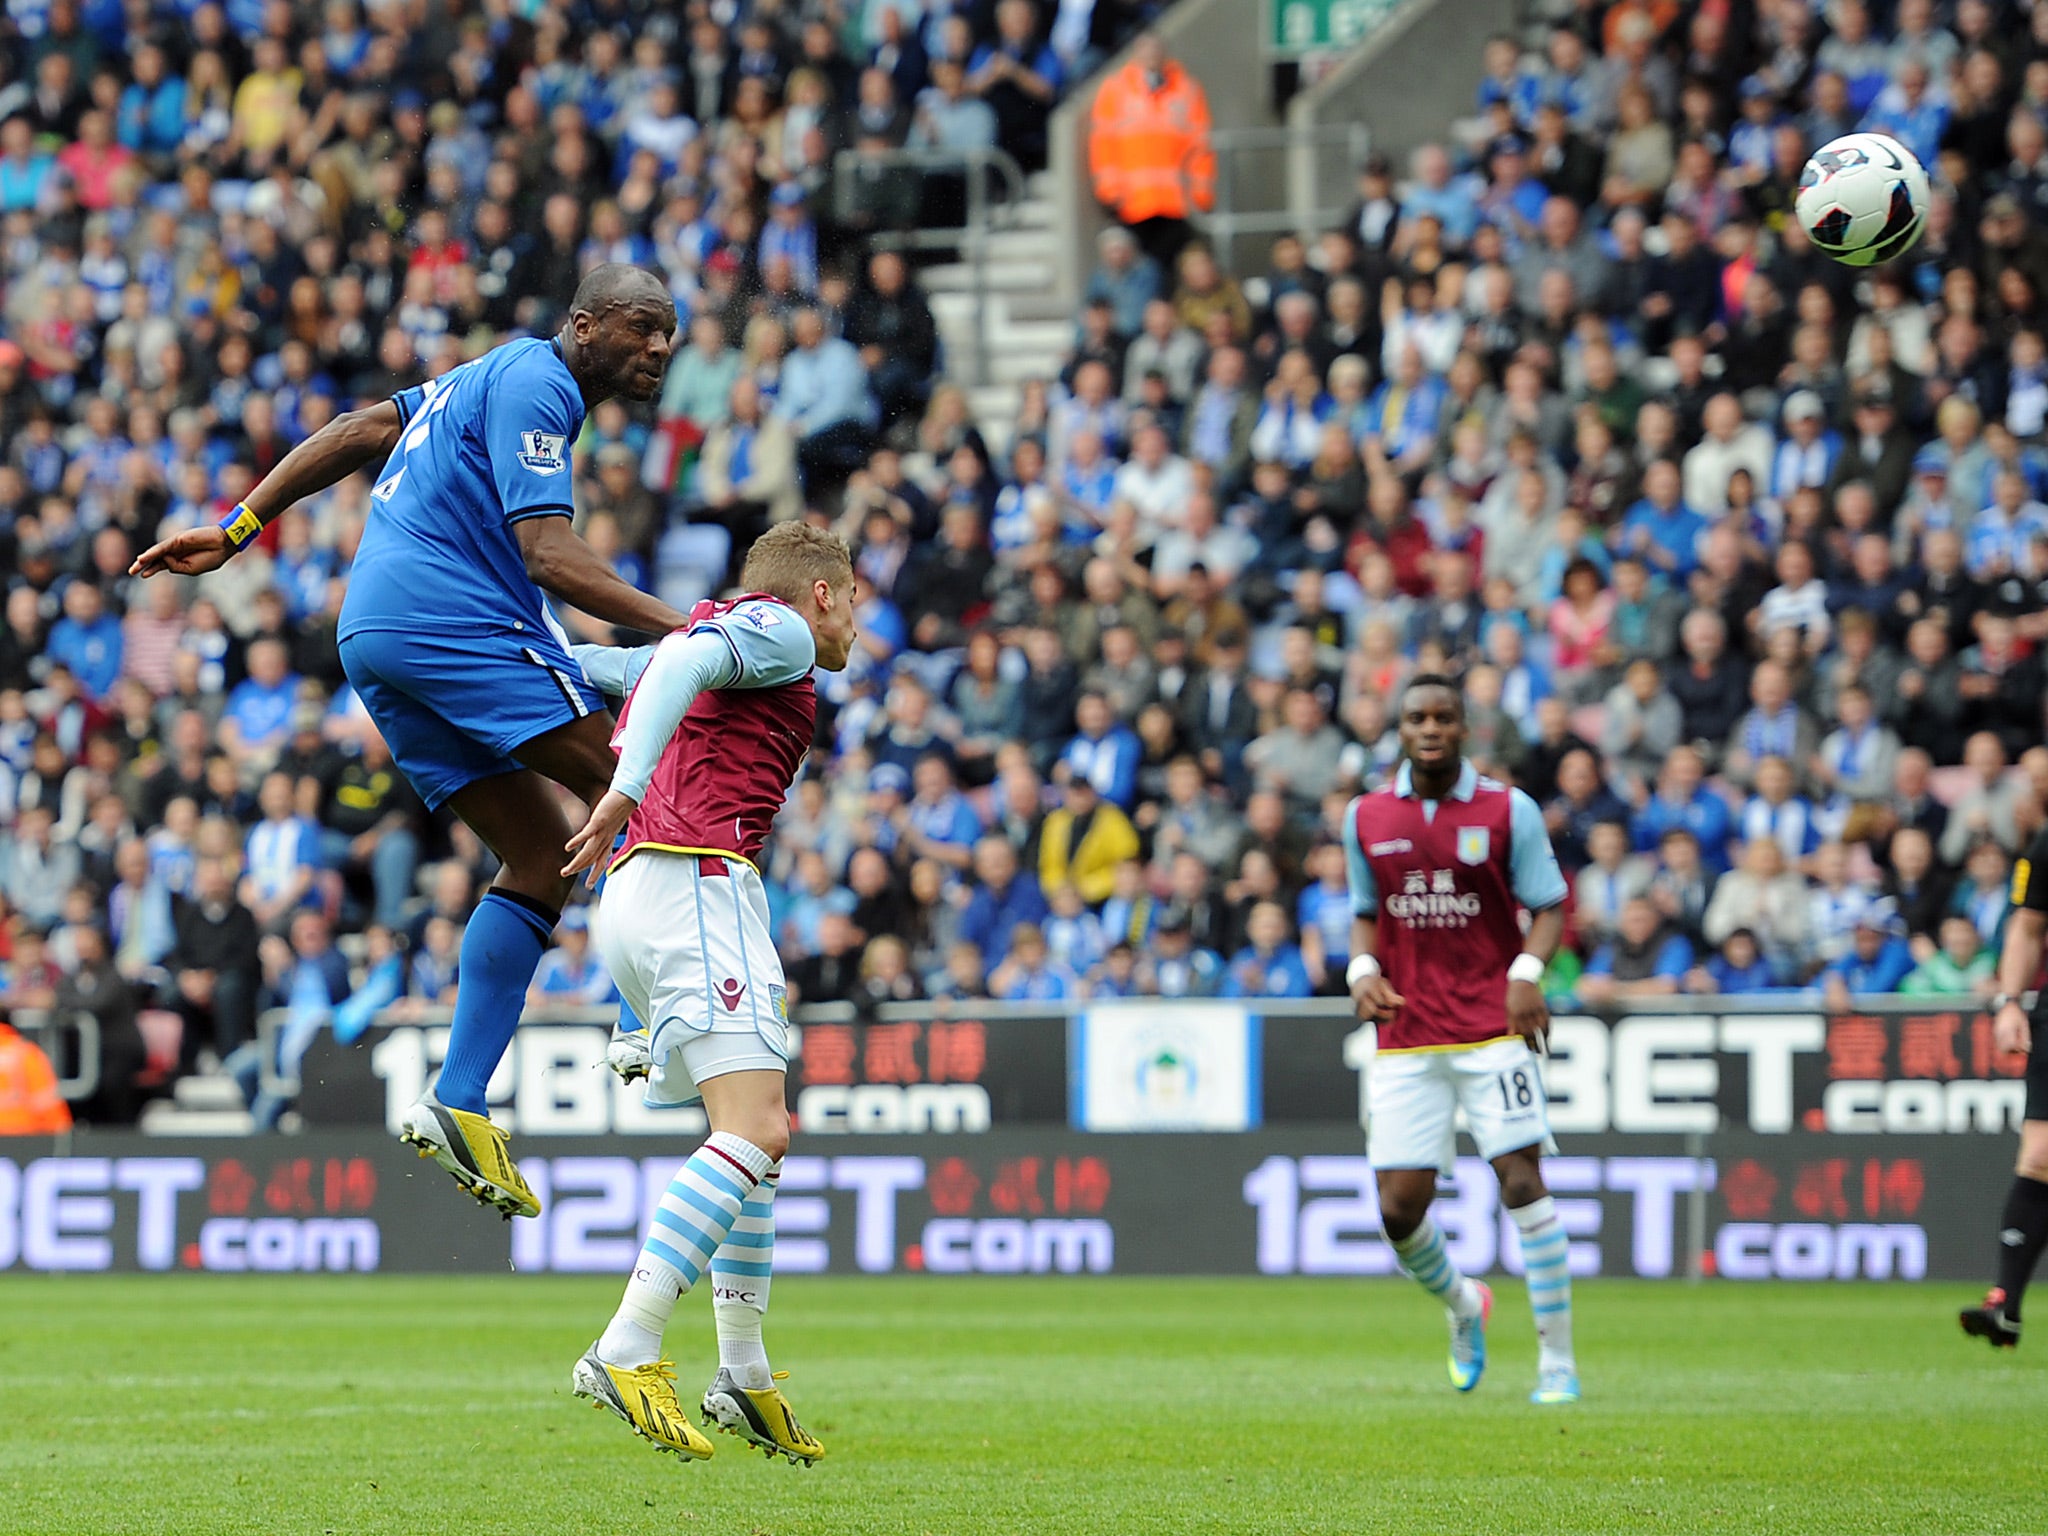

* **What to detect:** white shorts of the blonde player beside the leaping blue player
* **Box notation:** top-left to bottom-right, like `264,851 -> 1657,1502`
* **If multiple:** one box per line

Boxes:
594,850 -> 788,1108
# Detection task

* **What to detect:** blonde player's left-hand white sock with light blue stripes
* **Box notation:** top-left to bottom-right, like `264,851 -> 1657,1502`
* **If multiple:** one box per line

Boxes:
598,1130 -> 768,1368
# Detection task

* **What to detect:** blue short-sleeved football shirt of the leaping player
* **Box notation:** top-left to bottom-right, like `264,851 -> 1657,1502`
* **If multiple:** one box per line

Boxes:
340,340 -> 584,643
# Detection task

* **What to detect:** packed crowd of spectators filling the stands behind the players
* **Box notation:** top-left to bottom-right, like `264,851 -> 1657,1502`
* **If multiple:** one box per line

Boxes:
0,0 -> 2048,1120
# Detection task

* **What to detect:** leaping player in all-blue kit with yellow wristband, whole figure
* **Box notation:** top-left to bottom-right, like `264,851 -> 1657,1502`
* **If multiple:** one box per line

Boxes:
133,264 -> 684,1217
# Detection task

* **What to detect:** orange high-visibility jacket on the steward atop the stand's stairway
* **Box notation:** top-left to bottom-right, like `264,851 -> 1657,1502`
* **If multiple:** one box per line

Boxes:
1087,59 -> 1217,223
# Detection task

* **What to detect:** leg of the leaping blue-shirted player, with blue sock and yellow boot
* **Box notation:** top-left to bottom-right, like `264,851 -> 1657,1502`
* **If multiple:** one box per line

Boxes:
403,711 -> 614,1217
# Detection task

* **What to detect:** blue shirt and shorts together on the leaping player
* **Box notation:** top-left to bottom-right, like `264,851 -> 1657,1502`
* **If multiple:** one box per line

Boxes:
340,340 -> 602,807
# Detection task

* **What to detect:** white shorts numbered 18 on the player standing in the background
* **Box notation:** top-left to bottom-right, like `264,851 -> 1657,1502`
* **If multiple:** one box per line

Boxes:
1366,1038 -> 1556,1174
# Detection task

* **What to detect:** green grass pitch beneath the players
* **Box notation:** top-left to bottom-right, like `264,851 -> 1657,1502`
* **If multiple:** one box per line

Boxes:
0,1276 -> 2048,1536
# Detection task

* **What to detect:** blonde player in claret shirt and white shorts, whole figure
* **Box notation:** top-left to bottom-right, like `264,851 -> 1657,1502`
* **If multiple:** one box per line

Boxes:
563,522 -> 854,1462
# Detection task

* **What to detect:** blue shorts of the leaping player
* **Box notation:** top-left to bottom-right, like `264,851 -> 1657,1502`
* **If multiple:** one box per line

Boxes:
342,629 -> 604,811
